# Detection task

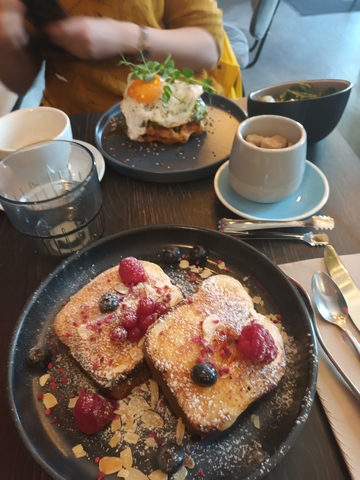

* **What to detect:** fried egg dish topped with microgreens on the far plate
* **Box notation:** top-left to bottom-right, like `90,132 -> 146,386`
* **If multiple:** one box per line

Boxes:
120,55 -> 211,144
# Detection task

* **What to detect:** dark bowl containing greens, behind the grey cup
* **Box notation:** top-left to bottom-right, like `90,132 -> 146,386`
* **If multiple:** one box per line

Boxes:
248,80 -> 353,144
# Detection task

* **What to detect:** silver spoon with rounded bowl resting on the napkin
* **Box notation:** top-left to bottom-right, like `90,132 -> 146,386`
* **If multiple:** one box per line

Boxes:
311,271 -> 360,356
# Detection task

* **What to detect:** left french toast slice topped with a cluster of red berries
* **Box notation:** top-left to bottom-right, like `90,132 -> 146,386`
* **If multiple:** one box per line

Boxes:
53,261 -> 183,399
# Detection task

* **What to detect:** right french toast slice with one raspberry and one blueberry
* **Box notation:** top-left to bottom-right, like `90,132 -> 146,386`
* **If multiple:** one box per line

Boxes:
145,275 -> 285,436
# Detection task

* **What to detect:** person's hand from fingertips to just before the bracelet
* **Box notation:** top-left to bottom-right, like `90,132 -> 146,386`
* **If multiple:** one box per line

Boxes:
44,16 -> 129,60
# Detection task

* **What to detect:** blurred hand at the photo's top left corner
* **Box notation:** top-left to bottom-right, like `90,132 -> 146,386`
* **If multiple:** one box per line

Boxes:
0,0 -> 28,49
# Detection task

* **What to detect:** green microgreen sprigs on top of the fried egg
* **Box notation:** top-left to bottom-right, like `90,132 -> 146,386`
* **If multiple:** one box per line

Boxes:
118,51 -> 216,105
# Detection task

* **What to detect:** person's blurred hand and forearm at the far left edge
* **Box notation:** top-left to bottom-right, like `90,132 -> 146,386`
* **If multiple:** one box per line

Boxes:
0,0 -> 41,95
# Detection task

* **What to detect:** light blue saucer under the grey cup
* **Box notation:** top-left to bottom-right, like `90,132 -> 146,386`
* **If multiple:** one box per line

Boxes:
214,160 -> 330,221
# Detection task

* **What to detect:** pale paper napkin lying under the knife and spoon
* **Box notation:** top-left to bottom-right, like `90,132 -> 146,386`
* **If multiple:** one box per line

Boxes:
280,254 -> 360,480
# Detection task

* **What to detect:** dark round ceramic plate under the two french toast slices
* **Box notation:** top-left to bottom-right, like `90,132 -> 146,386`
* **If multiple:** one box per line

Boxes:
8,225 -> 317,480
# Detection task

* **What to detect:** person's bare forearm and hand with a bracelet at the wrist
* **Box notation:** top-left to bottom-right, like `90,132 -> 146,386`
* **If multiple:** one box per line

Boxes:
45,17 -> 219,71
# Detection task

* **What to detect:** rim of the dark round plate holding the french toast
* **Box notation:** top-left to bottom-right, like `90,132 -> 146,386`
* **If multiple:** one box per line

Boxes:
6,224 -> 318,480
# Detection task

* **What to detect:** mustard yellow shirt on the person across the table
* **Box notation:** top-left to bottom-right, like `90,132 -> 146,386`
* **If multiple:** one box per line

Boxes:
31,0 -> 228,114
